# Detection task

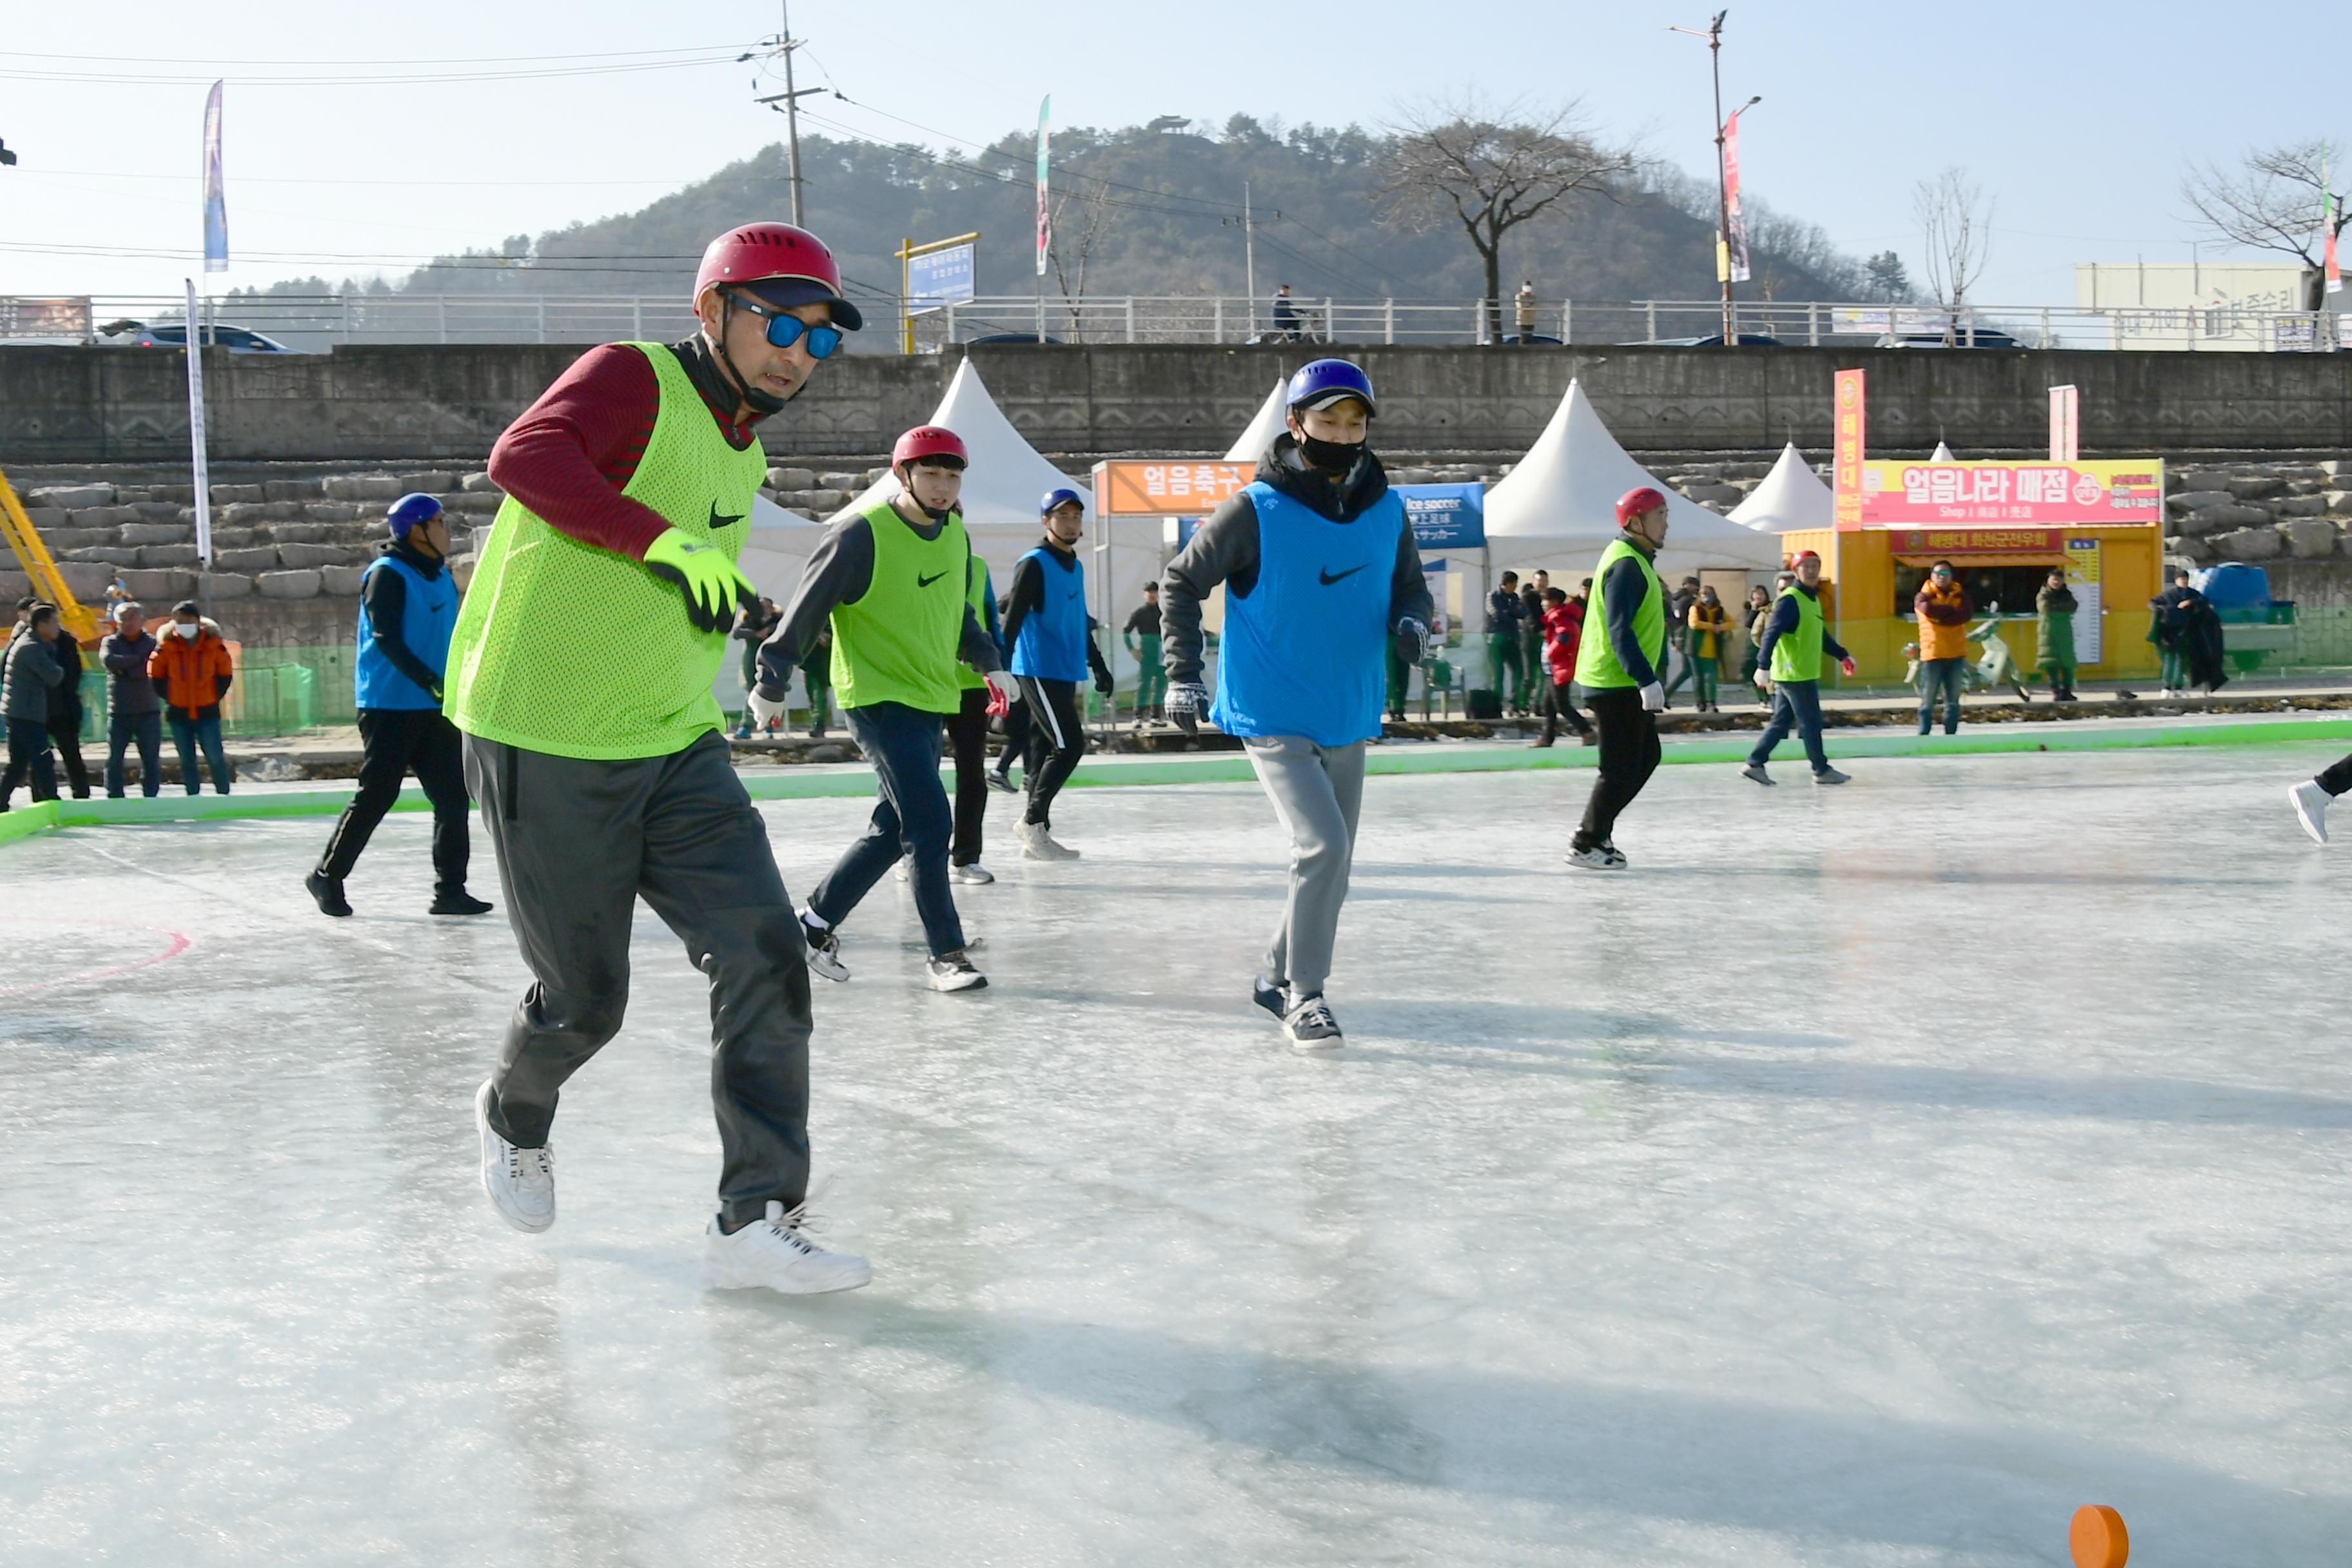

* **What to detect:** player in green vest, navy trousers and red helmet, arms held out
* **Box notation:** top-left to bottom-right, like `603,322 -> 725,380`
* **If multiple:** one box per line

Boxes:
750,426 -> 1014,992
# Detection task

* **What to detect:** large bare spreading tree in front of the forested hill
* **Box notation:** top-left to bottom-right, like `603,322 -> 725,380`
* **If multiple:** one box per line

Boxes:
1371,96 -> 1634,341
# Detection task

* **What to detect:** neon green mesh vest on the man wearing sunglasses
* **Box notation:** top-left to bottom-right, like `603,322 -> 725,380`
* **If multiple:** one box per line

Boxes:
447,343 -> 767,760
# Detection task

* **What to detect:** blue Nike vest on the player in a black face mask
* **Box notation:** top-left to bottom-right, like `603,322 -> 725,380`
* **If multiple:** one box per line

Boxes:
1209,482 -> 1404,745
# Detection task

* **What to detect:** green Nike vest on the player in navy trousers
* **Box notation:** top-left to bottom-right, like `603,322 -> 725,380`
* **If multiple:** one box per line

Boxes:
832,501 -> 972,712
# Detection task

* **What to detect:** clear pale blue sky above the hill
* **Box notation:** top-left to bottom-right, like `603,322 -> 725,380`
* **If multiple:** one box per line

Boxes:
0,0 -> 2352,303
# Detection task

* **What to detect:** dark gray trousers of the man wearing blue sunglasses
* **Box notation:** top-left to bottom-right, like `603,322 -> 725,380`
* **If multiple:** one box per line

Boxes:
466,731 -> 809,1225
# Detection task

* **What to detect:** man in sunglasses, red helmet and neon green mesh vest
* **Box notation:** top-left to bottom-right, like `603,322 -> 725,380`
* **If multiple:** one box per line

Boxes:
447,223 -> 872,1295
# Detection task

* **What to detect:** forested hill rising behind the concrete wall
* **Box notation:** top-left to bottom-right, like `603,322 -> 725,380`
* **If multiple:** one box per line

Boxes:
243,115 -> 1861,312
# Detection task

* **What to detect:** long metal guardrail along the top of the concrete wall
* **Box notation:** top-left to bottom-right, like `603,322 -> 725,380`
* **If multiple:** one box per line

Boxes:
0,294 -> 2352,353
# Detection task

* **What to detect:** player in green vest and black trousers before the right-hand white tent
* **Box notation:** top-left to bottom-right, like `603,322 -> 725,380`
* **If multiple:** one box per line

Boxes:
1569,484 -> 1665,872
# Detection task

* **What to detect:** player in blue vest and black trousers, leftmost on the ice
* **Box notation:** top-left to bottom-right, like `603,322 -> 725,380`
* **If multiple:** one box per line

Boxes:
304,494 -> 489,914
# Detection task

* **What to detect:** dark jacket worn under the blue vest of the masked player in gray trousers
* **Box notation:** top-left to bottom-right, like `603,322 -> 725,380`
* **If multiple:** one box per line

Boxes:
1159,430 -> 1435,681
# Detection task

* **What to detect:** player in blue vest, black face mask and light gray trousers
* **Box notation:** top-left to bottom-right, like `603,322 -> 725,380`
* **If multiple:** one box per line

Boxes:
1159,360 -> 1433,1048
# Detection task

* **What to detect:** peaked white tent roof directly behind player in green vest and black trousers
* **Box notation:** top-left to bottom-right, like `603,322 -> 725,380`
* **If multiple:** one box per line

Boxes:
1487,381 -> 1781,571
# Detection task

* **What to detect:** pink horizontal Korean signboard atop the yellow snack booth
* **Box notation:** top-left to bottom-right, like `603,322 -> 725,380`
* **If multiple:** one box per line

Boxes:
1839,458 -> 2164,531
